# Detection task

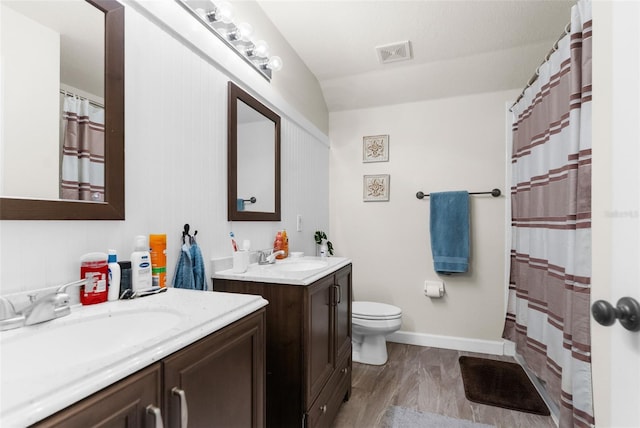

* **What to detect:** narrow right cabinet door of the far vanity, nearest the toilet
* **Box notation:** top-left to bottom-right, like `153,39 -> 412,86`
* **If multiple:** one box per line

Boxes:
334,266 -> 351,359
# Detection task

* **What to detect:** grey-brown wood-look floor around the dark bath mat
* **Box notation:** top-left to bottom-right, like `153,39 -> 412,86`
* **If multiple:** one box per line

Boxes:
333,342 -> 556,428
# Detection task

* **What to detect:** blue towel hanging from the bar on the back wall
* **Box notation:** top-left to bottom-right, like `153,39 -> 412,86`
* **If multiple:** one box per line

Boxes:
429,191 -> 469,274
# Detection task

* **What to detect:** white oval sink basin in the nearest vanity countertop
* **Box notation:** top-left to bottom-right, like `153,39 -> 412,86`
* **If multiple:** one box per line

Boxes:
0,310 -> 182,377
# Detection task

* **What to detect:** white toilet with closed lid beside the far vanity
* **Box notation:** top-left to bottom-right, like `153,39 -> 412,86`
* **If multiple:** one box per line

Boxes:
351,302 -> 402,366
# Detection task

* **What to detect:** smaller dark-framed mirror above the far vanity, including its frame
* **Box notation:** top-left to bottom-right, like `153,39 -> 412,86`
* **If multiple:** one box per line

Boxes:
227,82 -> 280,221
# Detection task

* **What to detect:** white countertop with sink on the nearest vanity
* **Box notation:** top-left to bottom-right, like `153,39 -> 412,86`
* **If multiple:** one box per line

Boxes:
0,288 -> 268,428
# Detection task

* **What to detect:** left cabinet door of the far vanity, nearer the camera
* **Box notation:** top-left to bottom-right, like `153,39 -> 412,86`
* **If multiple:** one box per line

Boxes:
305,275 -> 335,408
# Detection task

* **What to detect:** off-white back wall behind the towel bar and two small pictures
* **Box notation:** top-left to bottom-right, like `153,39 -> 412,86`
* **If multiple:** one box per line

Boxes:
329,91 -> 519,341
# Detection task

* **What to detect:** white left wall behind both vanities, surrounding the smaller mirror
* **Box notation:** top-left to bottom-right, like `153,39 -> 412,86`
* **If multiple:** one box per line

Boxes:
0,2 -> 329,295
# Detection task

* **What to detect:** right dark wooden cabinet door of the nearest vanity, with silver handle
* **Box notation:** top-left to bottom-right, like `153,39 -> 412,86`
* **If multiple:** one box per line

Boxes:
164,309 -> 265,428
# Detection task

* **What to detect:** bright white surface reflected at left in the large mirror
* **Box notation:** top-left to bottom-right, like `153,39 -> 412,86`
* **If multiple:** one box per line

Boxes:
0,4 -> 60,199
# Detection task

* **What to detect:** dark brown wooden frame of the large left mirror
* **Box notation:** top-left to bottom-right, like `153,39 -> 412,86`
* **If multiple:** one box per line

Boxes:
0,0 -> 125,220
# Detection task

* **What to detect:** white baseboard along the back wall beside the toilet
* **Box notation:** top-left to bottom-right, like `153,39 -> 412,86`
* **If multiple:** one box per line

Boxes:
387,331 -> 512,355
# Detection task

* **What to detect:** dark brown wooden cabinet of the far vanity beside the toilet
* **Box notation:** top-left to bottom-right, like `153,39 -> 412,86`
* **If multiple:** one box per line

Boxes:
213,264 -> 352,428
